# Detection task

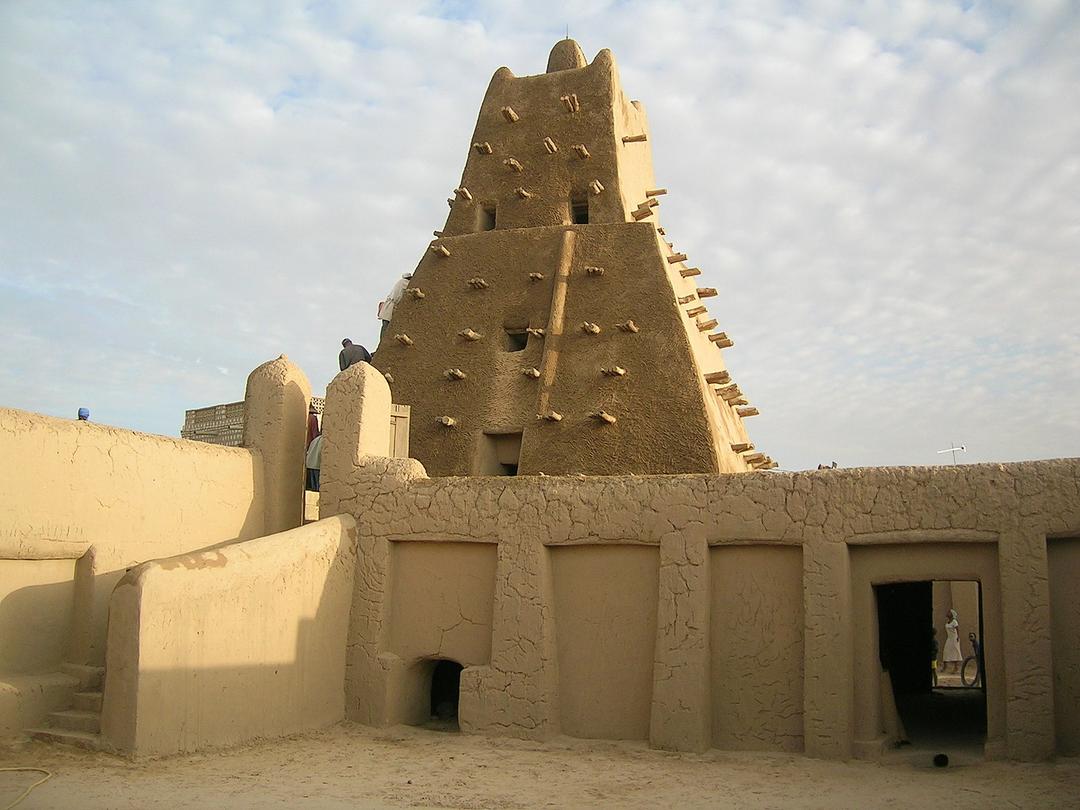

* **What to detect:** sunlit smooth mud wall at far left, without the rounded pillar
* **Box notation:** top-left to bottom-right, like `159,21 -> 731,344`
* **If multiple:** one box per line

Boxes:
0,409 -> 264,673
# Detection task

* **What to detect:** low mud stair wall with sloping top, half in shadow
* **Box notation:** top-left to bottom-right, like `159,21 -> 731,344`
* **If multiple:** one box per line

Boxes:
102,516 -> 356,755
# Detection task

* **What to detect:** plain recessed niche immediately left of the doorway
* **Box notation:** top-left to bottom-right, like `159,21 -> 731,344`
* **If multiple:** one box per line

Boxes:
710,545 -> 804,751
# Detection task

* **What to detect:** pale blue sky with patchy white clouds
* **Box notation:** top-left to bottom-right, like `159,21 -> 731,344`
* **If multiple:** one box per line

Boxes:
0,0 -> 1080,470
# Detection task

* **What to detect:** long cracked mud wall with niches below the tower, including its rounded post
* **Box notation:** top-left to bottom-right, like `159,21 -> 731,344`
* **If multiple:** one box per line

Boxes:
322,365 -> 1080,759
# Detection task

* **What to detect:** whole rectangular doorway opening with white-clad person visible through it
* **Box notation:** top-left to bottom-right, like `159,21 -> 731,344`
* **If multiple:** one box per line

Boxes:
874,580 -> 986,751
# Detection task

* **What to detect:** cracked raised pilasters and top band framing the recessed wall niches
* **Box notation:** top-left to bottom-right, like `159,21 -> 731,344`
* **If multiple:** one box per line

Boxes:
323,364 -> 1080,759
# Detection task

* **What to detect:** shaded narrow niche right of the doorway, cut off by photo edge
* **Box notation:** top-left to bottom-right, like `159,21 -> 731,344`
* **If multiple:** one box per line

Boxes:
1047,537 -> 1080,756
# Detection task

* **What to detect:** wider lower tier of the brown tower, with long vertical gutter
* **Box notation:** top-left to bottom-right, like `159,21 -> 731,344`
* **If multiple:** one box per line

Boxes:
374,224 -> 750,475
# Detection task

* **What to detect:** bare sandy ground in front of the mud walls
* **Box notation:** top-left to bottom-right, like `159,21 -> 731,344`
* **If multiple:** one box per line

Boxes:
0,724 -> 1080,810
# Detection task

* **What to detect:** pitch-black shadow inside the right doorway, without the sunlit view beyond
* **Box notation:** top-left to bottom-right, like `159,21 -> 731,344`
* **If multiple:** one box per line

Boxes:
874,580 -> 986,755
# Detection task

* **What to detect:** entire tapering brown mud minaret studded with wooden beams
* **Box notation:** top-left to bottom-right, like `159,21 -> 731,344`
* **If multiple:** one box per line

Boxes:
373,39 -> 775,475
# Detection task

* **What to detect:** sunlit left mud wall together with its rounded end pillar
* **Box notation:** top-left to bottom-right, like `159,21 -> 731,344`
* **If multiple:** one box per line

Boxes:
0,356 -> 310,737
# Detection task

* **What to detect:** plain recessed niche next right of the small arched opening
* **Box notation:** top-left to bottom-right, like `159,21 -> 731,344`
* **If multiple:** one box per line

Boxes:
550,545 -> 660,740
